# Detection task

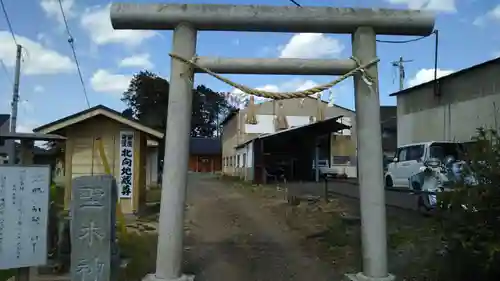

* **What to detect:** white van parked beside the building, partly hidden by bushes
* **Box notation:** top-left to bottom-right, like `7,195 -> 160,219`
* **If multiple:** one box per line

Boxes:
385,141 -> 464,188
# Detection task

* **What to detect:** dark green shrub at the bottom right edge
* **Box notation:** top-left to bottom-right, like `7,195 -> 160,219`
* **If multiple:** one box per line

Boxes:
434,129 -> 500,281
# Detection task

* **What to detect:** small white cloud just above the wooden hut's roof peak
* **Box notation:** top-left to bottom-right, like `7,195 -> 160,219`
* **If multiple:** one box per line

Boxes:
90,69 -> 132,94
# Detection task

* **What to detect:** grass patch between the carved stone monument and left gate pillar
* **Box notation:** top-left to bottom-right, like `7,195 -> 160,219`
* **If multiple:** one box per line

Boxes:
119,232 -> 158,281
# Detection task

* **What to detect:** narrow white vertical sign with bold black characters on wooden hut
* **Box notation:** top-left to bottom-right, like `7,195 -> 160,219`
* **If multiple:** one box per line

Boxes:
118,131 -> 134,198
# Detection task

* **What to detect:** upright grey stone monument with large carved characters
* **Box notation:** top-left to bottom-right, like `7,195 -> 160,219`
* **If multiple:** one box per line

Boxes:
71,175 -> 118,281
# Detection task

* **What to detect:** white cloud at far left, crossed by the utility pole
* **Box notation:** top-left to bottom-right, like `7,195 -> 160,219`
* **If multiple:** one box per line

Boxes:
0,31 -> 76,75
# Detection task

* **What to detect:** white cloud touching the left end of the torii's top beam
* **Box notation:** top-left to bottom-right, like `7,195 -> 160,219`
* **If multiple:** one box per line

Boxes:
80,4 -> 157,47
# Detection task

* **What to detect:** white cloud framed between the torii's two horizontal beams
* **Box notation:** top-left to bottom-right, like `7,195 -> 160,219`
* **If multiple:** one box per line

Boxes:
278,33 -> 344,59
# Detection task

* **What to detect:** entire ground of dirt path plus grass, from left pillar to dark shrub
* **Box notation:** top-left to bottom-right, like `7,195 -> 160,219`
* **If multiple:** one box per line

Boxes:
181,175 -> 433,281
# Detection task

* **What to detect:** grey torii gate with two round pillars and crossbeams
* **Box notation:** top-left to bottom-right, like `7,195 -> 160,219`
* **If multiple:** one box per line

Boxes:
111,3 -> 435,281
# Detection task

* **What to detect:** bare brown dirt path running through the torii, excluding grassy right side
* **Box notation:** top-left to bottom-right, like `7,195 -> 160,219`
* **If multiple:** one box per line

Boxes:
185,176 -> 339,281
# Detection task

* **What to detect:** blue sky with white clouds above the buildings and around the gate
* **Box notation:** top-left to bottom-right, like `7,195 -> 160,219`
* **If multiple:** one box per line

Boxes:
0,0 -> 500,131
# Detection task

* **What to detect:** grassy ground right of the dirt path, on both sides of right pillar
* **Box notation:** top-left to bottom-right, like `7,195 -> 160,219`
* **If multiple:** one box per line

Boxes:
248,182 -> 440,281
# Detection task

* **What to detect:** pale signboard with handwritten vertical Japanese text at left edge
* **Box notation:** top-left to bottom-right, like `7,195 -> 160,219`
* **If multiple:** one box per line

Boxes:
0,165 -> 50,269
